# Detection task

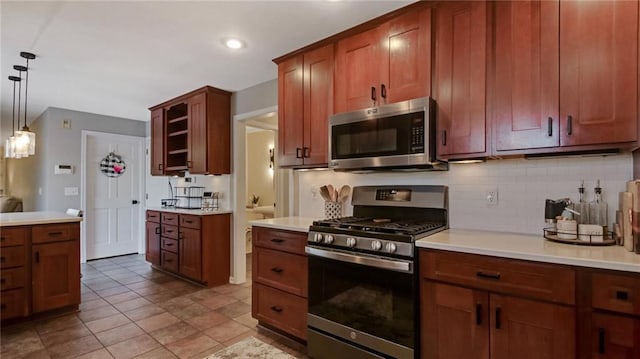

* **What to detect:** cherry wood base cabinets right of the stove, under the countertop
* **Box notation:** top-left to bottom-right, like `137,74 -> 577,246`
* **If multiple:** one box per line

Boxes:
419,249 -> 640,359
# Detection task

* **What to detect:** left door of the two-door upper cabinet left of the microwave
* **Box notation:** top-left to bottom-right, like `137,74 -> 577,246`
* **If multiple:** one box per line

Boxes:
278,55 -> 304,166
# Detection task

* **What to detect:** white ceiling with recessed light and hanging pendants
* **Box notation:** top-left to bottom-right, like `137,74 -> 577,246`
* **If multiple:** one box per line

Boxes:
0,0 -> 413,137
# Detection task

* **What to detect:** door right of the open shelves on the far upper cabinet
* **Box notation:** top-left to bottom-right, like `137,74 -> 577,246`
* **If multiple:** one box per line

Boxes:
187,93 -> 208,174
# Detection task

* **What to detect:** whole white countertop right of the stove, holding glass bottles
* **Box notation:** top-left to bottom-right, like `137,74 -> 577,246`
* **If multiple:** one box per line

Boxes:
416,229 -> 640,273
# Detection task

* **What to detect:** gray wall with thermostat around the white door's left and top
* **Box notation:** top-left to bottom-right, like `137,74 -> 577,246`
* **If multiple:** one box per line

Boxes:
7,107 -> 146,211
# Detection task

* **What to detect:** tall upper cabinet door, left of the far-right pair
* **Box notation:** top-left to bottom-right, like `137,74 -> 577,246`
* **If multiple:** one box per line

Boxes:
493,1 -> 560,151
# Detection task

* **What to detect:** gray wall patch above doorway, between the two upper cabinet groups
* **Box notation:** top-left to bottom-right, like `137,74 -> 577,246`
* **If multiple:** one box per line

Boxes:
231,79 -> 278,115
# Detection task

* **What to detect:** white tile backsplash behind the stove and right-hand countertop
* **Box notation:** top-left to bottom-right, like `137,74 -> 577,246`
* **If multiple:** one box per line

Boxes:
294,153 -> 633,234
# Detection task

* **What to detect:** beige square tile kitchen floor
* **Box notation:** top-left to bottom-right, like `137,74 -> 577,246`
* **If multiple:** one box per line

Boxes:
0,255 -> 306,359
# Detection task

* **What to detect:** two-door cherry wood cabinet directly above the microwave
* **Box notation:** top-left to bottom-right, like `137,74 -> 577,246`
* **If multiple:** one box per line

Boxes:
334,7 -> 431,113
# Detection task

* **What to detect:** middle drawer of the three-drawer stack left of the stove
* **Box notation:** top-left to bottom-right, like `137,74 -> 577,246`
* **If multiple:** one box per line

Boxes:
253,247 -> 308,297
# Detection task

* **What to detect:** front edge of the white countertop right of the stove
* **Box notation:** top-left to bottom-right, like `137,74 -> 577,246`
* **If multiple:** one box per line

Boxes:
416,241 -> 640,273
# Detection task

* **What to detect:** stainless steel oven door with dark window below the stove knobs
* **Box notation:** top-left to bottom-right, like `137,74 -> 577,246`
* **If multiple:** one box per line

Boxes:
306,246 -> 417,358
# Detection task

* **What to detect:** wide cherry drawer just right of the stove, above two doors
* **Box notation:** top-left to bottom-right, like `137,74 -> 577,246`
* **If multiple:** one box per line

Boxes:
420,250 -> 576,304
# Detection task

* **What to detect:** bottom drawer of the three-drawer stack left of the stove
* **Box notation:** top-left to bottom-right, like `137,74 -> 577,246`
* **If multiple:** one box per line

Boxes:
252,283 -> 307,339
